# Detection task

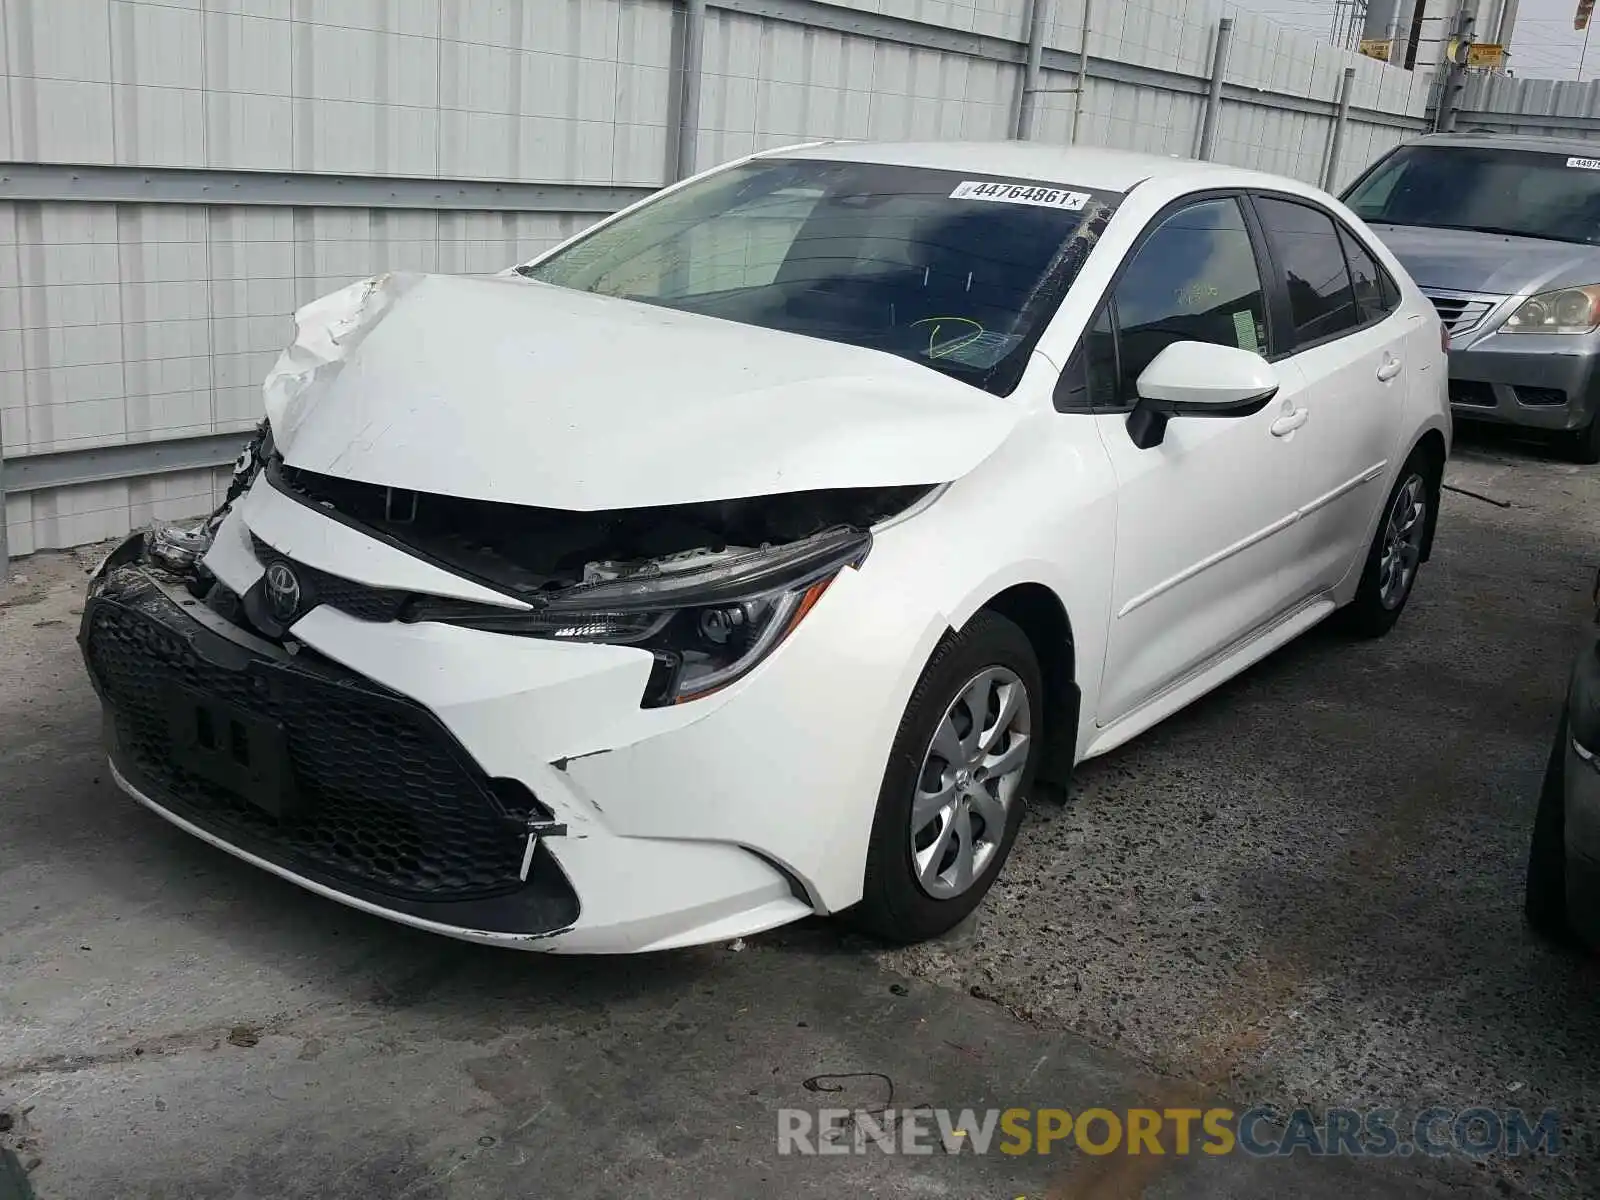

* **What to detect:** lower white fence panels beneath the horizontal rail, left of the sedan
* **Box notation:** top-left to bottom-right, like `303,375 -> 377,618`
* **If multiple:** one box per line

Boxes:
0,202 -> 592,554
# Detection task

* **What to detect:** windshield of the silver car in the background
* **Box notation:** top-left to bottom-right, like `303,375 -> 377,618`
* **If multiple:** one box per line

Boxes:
1346,146 -> 1600,245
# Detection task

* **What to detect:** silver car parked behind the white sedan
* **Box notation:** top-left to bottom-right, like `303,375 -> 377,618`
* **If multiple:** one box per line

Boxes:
1344,134 -> 1600,462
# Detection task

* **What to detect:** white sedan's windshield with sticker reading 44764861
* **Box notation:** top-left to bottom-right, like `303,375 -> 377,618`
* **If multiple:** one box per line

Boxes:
518,158 -> 1120,395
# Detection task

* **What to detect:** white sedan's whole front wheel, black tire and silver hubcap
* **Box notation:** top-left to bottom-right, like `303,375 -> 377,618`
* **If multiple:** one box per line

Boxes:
853,611 -> 1045,942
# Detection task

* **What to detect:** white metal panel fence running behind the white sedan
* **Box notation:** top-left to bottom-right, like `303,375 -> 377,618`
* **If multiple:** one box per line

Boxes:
0,0 -> 1429,554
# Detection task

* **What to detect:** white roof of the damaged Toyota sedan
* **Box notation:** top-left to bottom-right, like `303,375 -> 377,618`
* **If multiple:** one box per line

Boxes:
766,141 -> 1315,194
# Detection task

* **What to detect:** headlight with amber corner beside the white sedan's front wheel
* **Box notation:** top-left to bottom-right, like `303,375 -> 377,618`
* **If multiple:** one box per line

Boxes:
405,528 -> 872,707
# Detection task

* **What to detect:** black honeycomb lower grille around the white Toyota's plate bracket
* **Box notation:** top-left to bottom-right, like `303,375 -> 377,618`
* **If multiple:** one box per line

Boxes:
83,589 -> 528,901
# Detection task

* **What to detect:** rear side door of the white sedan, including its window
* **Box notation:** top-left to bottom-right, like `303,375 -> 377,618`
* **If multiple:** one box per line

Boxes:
1253,194 -> 1413,598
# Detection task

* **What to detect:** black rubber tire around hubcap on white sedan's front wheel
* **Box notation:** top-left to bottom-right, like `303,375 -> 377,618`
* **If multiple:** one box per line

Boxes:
850,611 -> 1048,942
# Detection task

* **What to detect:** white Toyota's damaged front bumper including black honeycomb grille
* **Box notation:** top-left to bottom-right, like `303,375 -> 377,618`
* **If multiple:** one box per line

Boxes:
82,492 -> 944,952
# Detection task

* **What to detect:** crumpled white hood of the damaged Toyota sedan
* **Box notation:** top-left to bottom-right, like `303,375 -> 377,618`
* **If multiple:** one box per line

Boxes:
266,275 -> 1021,510
